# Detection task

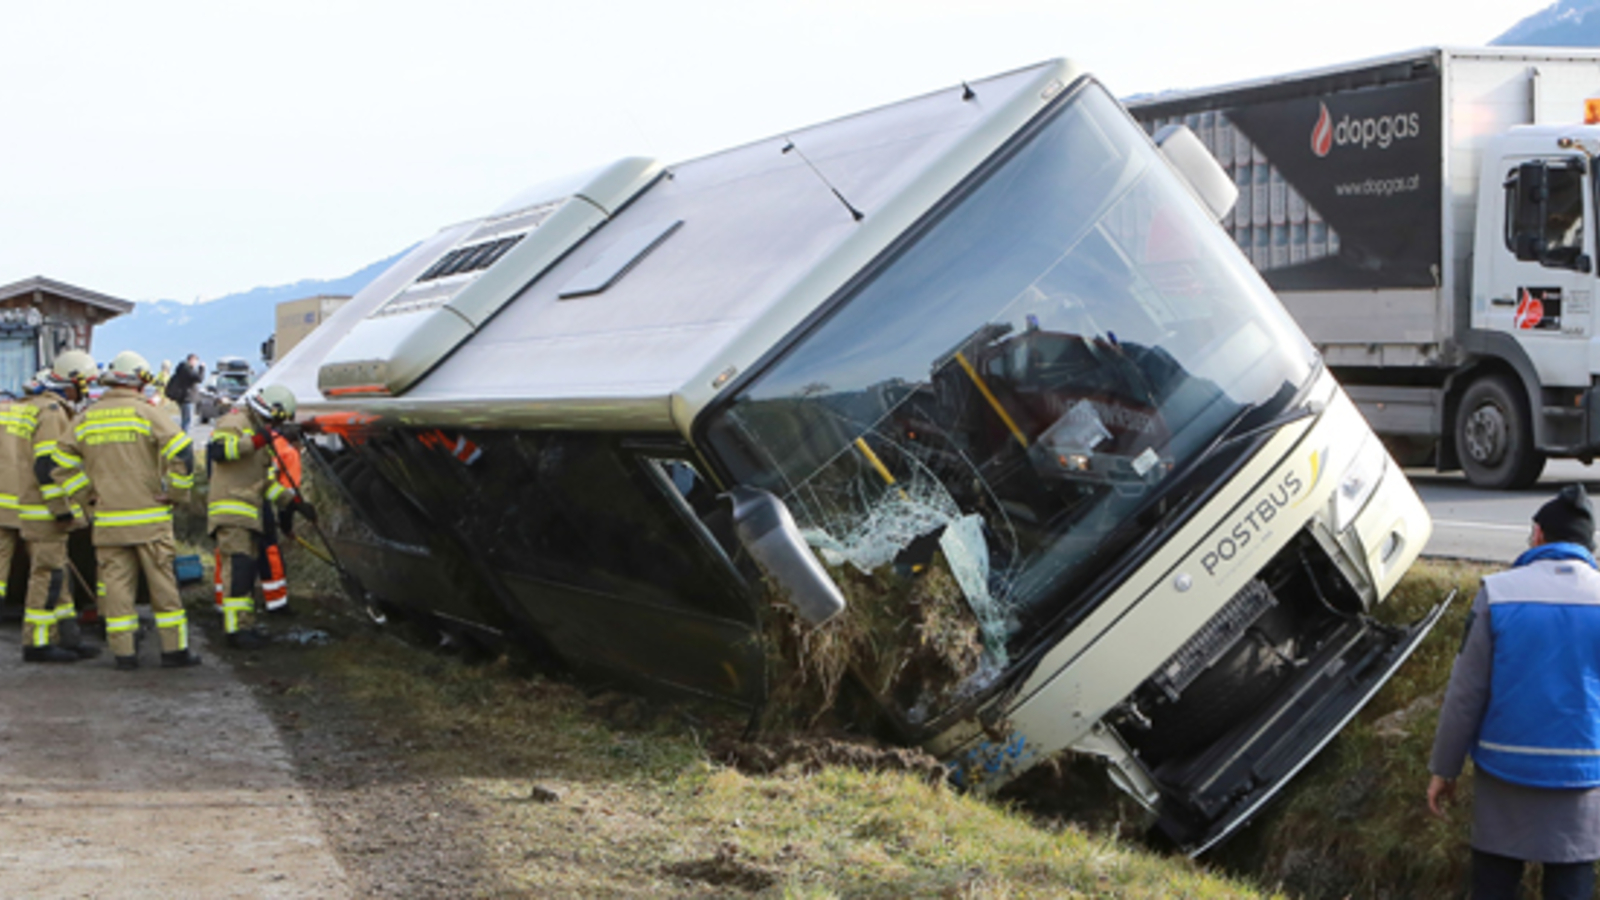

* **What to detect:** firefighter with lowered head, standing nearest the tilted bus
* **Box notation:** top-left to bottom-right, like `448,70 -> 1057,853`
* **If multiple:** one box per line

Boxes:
206,384 -> 317,650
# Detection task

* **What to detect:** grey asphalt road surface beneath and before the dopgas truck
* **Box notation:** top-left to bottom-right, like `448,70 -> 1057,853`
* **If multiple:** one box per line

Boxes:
1406,460 -> 1600,562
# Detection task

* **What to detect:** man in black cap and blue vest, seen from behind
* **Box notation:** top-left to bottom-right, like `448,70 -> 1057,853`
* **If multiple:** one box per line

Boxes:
1427,485 -> 1600,900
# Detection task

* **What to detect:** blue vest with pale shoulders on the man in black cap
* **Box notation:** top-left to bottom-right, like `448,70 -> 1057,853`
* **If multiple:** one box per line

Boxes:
1472,560 -> 1600,788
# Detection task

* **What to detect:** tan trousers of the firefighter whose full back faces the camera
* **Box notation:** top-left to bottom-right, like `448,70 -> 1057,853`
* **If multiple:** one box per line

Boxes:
94,536 -> 189,657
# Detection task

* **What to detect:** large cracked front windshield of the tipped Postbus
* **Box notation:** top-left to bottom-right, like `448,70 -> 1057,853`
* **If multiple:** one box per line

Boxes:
706,83 -> 1315,666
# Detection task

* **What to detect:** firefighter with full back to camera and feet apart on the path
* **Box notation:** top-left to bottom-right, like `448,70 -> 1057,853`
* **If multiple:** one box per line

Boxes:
53,351 -> 200,669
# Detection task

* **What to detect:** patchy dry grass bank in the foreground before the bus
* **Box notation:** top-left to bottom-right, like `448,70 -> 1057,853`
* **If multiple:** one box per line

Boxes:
275,608 -> 1261,898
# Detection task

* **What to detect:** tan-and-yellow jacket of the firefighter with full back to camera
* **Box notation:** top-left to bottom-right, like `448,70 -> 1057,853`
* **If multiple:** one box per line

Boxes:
51,381 -> 195,546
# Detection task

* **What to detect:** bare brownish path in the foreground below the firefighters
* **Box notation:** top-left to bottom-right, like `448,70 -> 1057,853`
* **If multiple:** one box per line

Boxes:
0,625 -> 350,898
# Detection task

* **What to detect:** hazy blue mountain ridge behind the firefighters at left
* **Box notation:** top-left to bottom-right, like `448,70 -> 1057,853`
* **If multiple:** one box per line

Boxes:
94,247 -> 411,370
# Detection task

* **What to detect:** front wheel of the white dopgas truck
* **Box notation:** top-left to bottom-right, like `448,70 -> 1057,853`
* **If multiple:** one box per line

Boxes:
1456,375 -> 1544,488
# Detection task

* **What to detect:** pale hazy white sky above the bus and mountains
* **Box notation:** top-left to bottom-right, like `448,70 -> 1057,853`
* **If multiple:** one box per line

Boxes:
0,0 -> 1547,299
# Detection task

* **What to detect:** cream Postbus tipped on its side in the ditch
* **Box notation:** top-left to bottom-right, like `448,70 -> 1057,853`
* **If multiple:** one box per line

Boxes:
264,61 -> 1438,852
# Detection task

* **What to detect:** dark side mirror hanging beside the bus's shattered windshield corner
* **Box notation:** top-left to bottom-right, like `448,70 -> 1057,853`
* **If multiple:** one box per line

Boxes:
726,485 -> 845,625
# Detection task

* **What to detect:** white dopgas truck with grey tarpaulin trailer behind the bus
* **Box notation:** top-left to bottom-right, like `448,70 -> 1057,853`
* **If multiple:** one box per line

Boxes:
1128,48 -> 1600,488
